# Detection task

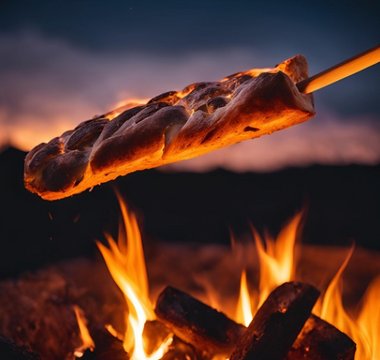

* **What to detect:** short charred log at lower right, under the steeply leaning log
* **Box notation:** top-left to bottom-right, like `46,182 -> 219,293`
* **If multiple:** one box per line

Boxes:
286,315 -> 356,360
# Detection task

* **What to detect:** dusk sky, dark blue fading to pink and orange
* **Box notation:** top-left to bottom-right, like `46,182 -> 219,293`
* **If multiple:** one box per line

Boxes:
0,0 -> 380,171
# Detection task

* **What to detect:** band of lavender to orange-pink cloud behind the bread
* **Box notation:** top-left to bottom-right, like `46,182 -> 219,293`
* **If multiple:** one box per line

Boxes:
0,31 -> 380,171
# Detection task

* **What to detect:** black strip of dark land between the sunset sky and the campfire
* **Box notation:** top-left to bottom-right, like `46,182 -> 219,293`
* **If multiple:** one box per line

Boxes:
0,148 -> 380,278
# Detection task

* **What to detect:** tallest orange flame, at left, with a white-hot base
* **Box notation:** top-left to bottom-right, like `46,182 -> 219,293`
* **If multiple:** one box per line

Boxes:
97,193 -> 172,360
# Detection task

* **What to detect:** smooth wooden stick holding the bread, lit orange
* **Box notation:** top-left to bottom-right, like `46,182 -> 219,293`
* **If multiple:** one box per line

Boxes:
297,44 -> 380,94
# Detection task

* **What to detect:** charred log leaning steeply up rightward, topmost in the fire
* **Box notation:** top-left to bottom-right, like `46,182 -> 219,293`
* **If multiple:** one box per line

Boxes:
230,282 -> 319,360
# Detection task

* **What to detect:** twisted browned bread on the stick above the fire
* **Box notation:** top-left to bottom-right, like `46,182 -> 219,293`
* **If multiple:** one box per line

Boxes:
24,55 -> 315,200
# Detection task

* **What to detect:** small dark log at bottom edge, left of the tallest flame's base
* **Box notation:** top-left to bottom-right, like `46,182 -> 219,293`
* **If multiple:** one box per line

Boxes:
76,324 -> 129,360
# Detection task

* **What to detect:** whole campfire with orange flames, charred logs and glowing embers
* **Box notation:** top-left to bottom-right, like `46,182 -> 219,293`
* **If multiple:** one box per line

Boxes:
1,195 -> 380,360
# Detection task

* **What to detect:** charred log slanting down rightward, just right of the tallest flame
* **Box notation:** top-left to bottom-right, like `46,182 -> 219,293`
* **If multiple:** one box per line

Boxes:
155,286 -> 246,356
